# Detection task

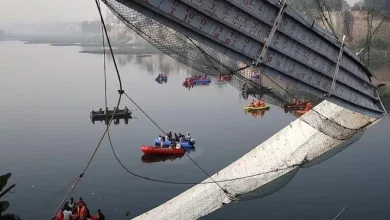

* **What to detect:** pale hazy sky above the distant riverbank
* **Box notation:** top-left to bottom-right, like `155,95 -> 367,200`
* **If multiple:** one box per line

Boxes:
0,0 -> 359,25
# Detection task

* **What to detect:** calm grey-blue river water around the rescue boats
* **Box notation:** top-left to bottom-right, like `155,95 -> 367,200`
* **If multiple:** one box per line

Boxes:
0,41 -> 390,219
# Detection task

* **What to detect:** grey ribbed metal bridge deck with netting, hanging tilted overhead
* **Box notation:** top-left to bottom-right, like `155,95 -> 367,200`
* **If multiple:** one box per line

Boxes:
104,0 -> 384,117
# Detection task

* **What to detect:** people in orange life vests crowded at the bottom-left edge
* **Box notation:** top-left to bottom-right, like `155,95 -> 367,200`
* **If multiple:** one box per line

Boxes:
55,197 -> 105,220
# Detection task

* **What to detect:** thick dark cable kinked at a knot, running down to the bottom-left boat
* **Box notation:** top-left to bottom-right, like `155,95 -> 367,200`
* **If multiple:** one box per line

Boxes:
54,0 -> 123,216
